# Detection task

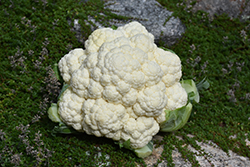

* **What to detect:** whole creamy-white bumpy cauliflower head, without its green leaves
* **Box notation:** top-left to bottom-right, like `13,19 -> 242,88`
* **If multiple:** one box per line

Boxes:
58,22 -> 188,149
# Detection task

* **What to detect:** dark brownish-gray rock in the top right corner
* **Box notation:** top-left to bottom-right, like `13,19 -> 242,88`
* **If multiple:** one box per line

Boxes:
186,0 -> 250,21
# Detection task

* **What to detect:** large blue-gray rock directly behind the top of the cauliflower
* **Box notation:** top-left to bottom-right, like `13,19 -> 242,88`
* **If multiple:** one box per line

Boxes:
103,0 -> 185,46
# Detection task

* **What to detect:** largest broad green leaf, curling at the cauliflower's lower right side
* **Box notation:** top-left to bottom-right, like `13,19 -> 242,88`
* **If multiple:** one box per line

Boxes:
160,103 -> 192,132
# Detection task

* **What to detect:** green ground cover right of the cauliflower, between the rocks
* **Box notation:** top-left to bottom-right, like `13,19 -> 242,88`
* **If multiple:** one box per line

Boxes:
156,1 -> 250,165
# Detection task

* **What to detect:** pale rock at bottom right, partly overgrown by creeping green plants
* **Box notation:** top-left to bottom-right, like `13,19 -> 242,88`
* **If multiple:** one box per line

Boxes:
144,135 -> 250,167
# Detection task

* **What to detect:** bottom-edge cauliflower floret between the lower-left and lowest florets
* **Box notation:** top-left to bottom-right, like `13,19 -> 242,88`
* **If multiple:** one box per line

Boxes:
82,99 -> 129,140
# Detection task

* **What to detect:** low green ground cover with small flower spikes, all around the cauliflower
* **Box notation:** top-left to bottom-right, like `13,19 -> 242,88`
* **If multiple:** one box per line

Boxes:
0,0 -> 250,166
